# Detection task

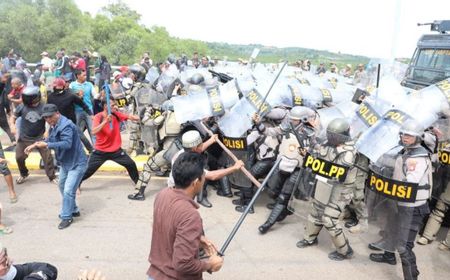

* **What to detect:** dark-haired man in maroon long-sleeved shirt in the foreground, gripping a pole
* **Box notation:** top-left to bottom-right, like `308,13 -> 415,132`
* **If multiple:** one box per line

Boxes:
147,152 -> 223,280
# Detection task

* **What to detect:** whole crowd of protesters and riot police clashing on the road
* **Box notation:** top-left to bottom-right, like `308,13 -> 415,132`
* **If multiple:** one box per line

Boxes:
0,46 -> 450,279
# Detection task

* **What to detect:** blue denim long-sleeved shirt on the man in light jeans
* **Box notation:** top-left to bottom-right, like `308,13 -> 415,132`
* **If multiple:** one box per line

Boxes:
47,115 -> 87,170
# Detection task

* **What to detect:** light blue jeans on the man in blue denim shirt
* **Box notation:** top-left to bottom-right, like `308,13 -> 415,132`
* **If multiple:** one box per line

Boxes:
59,162 -> 87,220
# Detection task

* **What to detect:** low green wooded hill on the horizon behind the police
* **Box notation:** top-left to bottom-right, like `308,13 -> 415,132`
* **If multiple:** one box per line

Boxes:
206,42 -> 370,68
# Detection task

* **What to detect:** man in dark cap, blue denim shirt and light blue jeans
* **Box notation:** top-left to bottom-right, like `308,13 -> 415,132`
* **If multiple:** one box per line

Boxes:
25,104 -> 87,229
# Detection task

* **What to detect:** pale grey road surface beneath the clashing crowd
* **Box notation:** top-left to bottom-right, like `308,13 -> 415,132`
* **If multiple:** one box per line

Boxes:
0,171 -> 450,280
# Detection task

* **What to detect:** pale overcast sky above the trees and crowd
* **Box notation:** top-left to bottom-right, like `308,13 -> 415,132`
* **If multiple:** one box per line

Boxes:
75,0 -> 450,58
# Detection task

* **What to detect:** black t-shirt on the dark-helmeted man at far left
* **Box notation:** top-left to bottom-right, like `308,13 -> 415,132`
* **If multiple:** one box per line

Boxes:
15,103 -> 45,141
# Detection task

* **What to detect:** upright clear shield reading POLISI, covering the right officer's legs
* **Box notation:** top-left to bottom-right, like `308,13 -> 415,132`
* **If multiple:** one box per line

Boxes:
361,158 -> 422,254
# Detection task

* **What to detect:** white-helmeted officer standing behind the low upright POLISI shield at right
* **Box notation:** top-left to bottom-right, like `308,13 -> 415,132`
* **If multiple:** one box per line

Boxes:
369,119 -> 432,280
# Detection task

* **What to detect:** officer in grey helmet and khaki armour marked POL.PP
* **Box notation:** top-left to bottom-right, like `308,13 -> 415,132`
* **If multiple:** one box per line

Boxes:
297,118 -> 356,260
